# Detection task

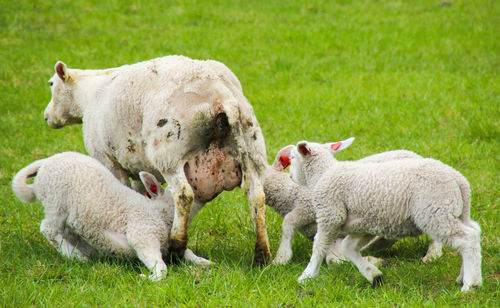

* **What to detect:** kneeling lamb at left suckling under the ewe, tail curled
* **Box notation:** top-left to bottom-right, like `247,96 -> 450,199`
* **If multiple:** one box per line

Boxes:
12,152 -> 211,281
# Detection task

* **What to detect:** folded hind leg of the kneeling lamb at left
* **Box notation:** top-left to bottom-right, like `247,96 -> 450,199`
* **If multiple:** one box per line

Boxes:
40,214 -> 87,260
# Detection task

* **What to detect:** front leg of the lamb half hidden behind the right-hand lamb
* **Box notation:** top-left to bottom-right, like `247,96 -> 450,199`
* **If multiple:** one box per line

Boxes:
273,207 -> 314,264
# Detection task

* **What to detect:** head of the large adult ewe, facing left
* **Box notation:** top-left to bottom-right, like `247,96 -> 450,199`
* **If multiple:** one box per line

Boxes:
44,61 -> 82,128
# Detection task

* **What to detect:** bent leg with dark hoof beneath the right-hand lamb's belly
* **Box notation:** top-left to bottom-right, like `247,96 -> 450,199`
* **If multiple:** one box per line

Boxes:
342,235 -> 382,286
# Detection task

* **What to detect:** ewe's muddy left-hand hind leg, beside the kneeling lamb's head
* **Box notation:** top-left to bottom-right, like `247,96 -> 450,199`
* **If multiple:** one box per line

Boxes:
163,166 -> 194,257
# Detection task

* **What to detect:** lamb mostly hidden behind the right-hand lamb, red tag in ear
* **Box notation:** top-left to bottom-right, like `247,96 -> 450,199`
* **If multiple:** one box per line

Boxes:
264,138 -> 442,265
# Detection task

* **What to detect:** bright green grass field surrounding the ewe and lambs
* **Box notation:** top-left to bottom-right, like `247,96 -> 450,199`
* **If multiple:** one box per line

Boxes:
0,0 -> 500,307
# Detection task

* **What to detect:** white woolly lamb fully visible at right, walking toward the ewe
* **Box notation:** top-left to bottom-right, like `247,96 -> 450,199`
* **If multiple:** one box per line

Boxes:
290,141 -> 482,292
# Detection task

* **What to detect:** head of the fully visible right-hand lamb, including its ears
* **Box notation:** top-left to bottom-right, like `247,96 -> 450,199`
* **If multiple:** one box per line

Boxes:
289,137 -> 354,188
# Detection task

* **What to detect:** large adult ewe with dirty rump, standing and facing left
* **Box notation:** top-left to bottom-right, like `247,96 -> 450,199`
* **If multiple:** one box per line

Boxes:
44,56 -> 271,264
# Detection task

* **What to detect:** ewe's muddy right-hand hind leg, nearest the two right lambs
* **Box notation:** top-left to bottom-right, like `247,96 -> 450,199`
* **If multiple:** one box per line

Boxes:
242,172 -> 271,265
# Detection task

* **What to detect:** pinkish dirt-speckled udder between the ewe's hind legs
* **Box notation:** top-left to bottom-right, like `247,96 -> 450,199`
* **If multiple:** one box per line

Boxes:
184,143 -> 242,202
